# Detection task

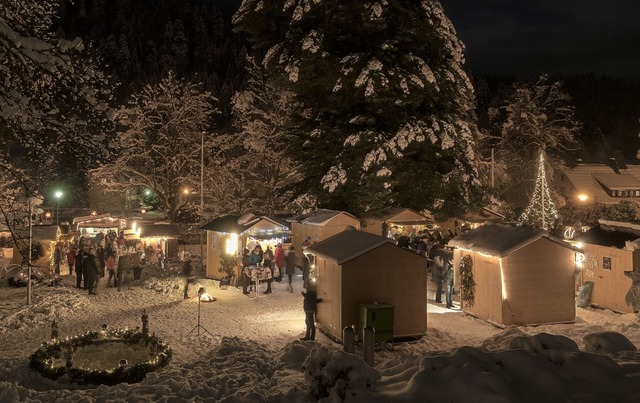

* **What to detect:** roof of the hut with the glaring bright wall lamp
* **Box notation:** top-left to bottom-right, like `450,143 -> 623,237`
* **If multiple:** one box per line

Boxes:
200,213 -> 291,239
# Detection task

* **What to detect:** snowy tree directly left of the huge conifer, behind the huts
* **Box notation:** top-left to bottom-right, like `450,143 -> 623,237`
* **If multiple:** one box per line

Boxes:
212,58 -> 299,215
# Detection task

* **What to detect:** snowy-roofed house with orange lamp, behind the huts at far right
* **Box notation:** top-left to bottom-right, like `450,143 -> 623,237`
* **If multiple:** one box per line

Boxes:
554,160 -> 640,206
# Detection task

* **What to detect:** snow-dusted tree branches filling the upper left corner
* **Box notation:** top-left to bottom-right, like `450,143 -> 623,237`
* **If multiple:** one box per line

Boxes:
0,0 -> 110,200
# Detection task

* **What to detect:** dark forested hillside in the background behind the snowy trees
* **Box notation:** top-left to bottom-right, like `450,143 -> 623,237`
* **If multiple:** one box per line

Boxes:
59,0 -> 640,164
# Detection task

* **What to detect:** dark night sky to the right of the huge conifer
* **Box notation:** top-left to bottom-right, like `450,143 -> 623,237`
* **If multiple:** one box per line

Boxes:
441,0 -> 640,79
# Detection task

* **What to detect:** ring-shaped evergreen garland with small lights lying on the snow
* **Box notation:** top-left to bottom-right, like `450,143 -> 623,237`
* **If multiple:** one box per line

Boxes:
29,329 -> 172,385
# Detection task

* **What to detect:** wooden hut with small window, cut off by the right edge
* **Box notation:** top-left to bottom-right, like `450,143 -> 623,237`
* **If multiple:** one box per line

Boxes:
576,220 -> 640,313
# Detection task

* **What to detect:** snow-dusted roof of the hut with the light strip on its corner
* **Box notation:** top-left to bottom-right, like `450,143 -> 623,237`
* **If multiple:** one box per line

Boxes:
448,221 -> 582,257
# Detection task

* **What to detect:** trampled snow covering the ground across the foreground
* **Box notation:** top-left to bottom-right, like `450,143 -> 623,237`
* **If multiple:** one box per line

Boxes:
0,273 -> 640,402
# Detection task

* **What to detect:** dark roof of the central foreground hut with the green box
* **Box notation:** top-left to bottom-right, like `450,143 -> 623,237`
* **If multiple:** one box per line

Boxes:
305,227 -> 395,265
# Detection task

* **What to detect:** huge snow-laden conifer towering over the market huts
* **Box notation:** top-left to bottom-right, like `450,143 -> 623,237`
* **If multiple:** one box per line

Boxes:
234,0 -> 482,219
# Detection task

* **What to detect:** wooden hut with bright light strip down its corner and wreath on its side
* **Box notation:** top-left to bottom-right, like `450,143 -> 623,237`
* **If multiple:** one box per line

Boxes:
448,222 -> 582,325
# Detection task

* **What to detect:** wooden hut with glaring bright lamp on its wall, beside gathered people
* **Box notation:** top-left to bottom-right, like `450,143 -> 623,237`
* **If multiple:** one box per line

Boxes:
200,213 -> 290,280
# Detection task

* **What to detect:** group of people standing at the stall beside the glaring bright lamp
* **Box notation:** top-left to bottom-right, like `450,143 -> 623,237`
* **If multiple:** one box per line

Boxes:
241,243 -> 296,295
